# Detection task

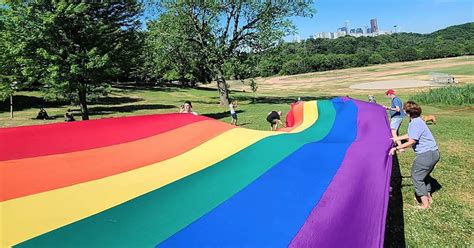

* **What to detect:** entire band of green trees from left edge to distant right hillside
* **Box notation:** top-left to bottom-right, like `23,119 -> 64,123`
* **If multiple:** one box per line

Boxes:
0,0 -> 474,119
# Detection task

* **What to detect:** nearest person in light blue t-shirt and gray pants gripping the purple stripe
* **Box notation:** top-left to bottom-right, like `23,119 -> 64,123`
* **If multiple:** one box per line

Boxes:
389,101 -> 440,209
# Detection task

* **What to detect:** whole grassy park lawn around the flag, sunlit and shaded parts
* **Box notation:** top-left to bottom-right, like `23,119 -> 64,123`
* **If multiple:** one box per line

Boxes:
0,57 -> 474,247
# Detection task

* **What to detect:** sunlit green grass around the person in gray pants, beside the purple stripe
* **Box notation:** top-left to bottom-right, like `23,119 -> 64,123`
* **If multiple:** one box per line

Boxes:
399,102 -> 474,247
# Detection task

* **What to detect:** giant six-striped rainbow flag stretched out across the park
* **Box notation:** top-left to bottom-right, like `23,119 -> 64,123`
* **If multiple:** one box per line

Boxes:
0,98 -> 391,247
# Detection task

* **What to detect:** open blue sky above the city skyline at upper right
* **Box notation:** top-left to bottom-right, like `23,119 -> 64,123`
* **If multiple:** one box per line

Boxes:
291,0 -> 474,39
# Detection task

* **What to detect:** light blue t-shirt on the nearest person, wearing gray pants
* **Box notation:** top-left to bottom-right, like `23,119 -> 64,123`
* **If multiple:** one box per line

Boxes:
408,117 -> 438,154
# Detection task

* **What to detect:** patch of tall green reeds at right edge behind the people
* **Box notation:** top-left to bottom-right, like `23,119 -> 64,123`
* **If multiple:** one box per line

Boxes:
412,84 -> 474,105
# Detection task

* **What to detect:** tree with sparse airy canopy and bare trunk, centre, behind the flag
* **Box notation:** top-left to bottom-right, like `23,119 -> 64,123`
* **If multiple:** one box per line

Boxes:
151,0 -> 313,106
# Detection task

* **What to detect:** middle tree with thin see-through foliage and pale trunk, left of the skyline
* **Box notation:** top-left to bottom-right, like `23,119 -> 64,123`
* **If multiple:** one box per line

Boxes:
144,0 -> 313,105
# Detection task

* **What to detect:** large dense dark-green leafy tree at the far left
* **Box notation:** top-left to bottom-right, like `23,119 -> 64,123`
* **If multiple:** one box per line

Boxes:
2,0 -> 141,120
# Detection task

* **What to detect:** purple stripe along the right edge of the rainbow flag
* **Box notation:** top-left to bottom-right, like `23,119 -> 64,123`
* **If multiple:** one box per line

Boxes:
290,100 -> 392,247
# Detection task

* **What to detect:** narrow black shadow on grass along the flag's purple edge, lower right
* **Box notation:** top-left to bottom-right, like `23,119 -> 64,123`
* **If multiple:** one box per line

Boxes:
384,155 -> 406,247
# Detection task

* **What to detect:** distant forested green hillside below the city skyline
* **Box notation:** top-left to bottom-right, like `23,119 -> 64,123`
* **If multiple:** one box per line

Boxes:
226,23 -> 474,79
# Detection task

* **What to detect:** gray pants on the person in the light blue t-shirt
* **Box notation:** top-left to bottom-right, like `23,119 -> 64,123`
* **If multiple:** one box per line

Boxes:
411,150 -> 439,196
